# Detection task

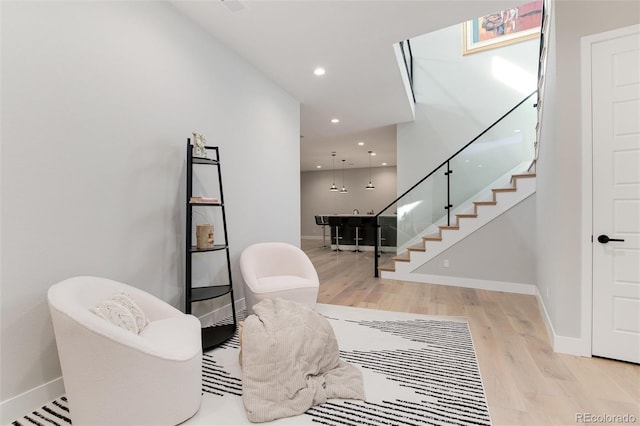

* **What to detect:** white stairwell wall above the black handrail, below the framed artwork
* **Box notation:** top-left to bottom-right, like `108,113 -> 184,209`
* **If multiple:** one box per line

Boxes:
397,20 -> 539,194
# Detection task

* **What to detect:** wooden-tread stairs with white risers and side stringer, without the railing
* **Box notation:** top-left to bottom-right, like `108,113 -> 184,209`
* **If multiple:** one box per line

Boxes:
378,173 -> 536,281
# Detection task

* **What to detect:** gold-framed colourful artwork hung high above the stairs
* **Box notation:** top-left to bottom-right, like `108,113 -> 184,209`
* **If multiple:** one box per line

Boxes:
462,0 -> 543,55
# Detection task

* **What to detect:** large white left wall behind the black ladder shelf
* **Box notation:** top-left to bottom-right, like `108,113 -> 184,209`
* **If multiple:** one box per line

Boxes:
0,1 -> 300,416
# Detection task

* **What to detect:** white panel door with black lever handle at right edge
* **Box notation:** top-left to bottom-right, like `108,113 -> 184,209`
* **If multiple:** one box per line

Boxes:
591,28 -> 640,363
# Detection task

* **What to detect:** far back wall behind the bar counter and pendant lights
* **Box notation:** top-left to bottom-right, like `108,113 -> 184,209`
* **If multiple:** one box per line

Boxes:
300,166 -> 396,238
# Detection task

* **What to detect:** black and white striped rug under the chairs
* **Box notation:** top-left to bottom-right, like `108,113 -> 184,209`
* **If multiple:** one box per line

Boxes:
13,305 -> 491,426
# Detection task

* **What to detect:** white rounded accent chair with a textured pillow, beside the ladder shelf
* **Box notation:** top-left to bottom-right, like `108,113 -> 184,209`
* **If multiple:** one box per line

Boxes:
47,276 -> 202,426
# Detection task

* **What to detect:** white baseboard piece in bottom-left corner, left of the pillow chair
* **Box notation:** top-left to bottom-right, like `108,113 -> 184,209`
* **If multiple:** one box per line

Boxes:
0,376 -> 64,425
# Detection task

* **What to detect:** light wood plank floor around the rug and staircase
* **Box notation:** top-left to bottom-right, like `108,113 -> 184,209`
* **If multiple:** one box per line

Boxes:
302,240 -> 640,425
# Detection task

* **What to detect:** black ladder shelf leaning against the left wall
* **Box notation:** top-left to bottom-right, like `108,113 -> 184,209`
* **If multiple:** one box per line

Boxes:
185,139 -> 237,351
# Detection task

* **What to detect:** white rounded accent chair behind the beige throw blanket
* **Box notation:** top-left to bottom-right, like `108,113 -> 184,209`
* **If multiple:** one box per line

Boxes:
240,242 -> 320,314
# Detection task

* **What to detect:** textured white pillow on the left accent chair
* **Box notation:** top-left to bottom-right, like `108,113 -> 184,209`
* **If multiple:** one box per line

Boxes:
89,293 -> 149,334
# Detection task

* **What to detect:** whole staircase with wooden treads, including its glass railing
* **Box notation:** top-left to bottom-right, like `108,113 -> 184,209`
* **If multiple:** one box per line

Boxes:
374,91 -> 537,286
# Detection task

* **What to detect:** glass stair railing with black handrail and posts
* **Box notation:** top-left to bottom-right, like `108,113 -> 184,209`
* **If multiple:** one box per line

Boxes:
374,92 -> 538,277
